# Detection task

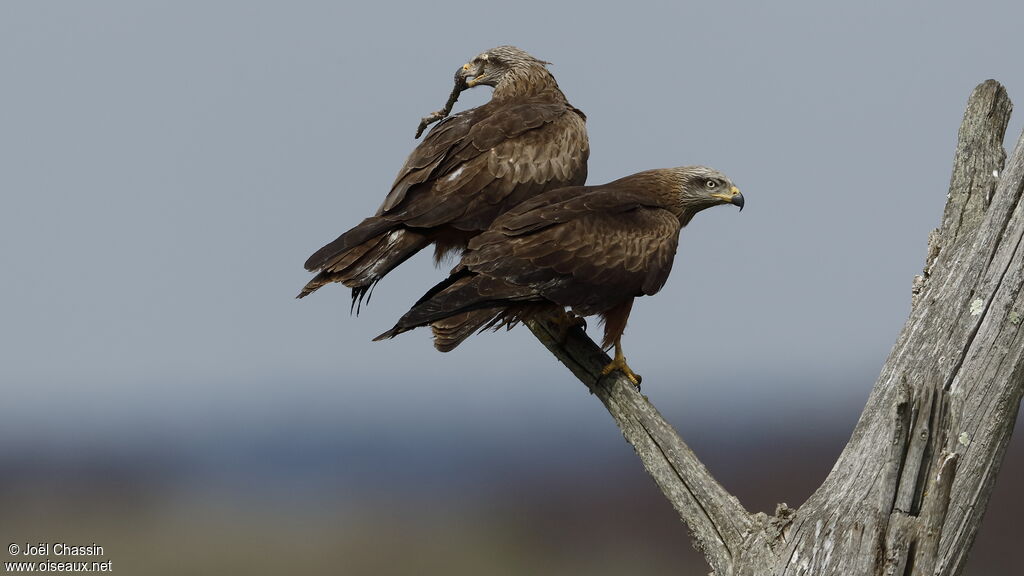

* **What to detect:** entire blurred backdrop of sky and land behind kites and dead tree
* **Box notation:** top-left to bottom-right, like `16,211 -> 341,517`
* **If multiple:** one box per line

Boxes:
0,1 -> 1024,575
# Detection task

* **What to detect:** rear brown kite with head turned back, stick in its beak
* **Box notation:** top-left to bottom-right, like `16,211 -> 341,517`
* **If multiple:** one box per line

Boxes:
298,46 -> 590,306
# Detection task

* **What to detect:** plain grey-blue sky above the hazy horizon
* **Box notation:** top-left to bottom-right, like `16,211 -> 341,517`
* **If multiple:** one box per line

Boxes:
0,2 -> 1024,444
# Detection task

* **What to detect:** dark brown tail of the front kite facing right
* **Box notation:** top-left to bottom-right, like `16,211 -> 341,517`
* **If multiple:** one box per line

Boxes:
374,270 -> 532,352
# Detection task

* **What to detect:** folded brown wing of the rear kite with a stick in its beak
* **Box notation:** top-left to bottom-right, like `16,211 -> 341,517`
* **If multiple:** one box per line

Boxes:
378,99 -> 590,231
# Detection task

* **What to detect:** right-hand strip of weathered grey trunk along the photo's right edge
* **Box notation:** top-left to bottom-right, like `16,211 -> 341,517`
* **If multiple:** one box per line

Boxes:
937,118 -> 1024,574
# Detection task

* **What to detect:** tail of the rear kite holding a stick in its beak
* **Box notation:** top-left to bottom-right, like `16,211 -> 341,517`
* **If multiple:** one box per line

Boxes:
297,216 -> 431,307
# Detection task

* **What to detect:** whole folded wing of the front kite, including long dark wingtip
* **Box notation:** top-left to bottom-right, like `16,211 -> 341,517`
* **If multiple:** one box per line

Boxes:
378,187 -> 680,340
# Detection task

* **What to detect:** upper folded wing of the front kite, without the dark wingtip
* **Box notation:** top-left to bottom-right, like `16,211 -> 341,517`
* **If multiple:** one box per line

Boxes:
461,187 -> 680,314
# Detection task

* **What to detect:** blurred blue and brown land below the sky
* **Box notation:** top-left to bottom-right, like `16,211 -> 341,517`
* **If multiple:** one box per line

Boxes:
0,393 -> 1024,575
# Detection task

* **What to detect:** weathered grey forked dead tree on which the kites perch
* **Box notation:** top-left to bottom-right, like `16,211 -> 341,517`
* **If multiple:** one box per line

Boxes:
527,80 -> 1024,576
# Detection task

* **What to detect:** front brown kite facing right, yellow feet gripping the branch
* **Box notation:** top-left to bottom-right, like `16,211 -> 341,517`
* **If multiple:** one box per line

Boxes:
376,166 -> 743,384
